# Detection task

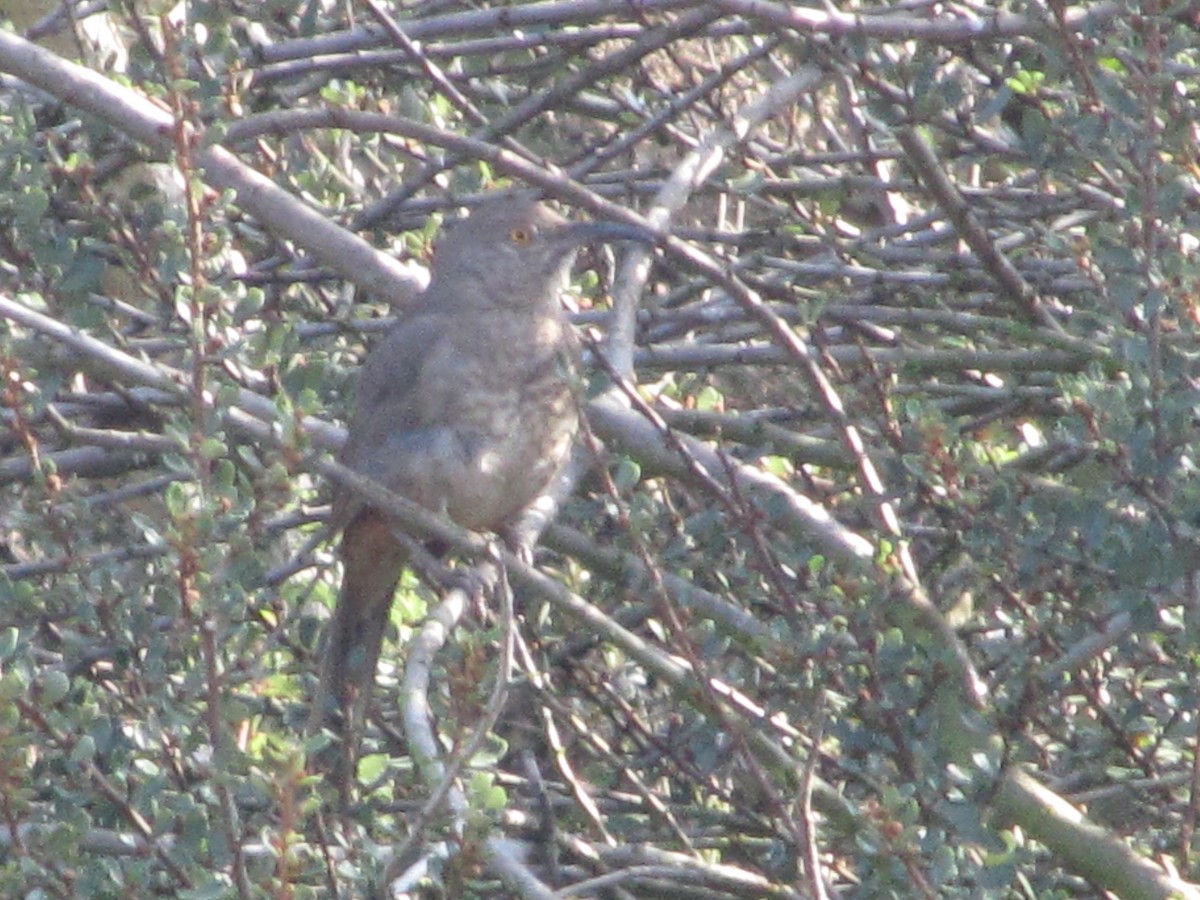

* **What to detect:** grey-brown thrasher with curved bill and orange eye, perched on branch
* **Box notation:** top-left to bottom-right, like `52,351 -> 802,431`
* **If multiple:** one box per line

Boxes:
310,194 -> 647,776
